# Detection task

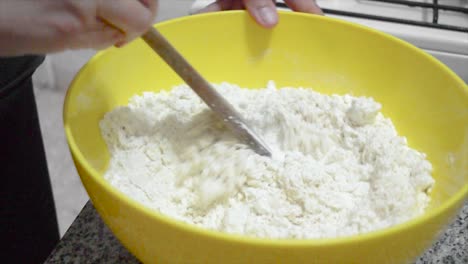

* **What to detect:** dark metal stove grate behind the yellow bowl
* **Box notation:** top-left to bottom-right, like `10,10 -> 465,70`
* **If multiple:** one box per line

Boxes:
276,0 -> 468,33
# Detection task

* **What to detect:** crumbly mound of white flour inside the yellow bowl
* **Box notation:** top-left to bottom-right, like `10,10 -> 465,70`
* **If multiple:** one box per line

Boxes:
100,82 -> 434,238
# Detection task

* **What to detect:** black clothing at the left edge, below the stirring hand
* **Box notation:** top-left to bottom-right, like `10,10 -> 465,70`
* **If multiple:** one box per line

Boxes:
0,56 -> 59,264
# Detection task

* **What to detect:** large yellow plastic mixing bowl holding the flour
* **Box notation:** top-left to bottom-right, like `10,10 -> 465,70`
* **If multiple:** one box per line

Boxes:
64,11 -> 468,263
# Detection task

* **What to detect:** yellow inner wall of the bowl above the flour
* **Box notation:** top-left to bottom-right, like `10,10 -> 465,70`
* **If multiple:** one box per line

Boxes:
64,11 -> 468,243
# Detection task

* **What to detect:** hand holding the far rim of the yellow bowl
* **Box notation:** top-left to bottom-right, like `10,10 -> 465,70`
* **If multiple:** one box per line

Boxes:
197,0 -> 323,28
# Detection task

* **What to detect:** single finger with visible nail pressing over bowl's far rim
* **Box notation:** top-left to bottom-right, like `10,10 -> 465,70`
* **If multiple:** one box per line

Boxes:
244,0 -> 278,28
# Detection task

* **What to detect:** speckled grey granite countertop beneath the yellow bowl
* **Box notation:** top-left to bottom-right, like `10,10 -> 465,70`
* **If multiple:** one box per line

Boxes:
45,201 -> 468,264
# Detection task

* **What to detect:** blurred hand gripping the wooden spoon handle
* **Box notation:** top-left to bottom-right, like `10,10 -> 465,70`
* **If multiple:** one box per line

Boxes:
0,0 -> 157,56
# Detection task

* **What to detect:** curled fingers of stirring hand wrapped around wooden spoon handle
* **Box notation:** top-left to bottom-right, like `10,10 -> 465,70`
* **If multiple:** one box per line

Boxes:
97,0 -> 157,41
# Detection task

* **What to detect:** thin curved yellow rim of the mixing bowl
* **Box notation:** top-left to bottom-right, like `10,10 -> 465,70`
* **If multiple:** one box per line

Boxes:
63,10 -> 468,247
